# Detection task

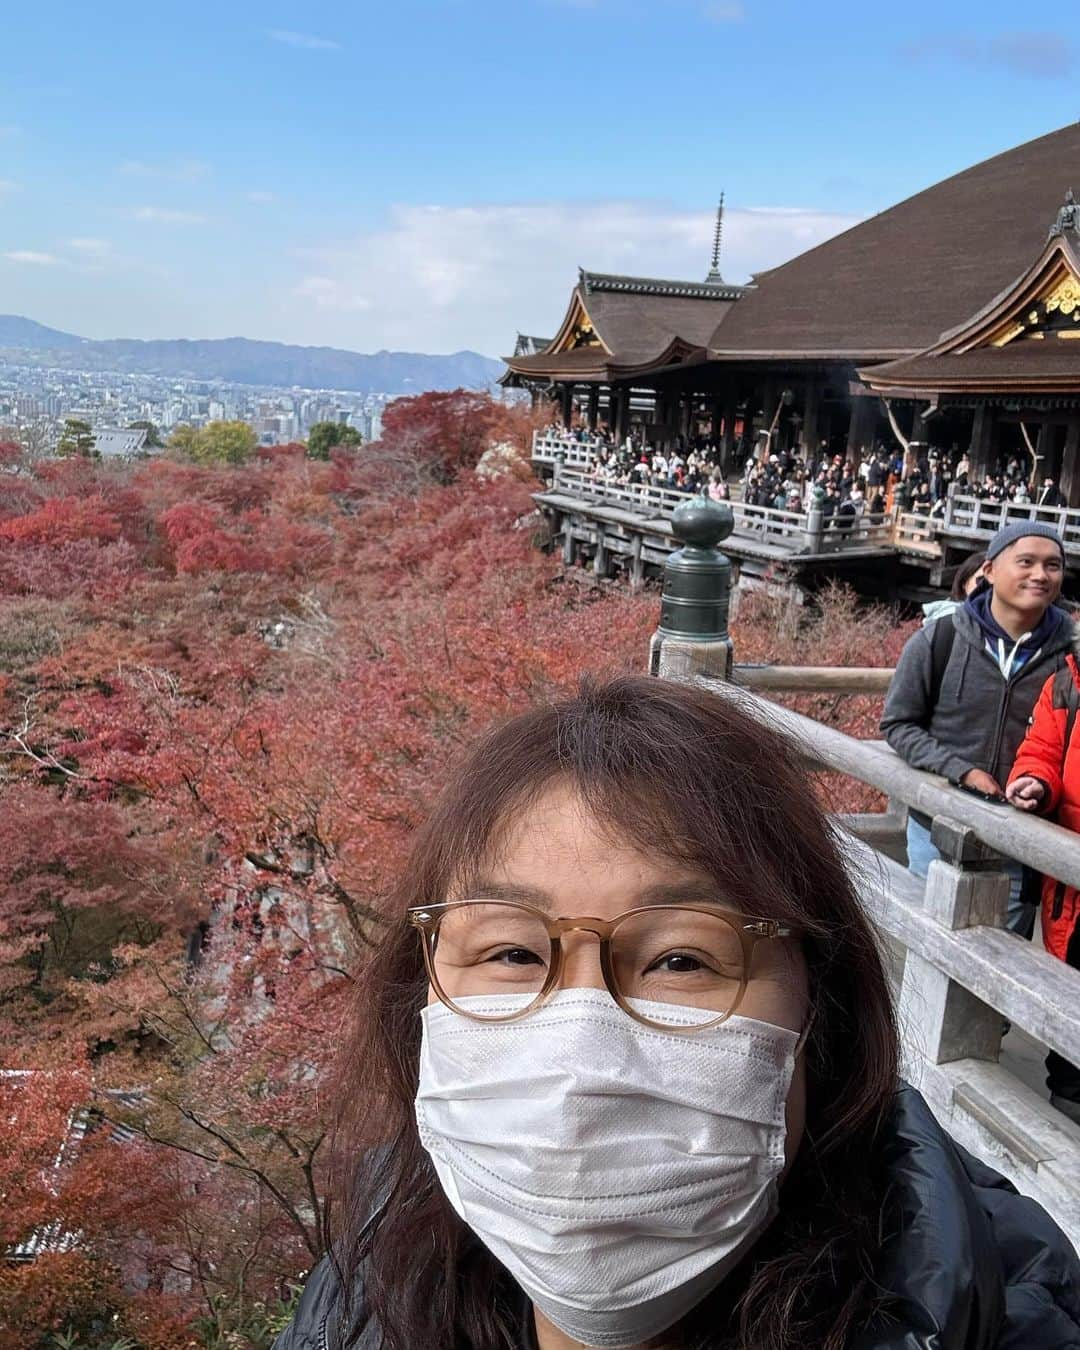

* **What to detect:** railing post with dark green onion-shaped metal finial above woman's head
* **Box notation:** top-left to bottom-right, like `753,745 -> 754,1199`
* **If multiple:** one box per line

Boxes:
649,497 -> 734,680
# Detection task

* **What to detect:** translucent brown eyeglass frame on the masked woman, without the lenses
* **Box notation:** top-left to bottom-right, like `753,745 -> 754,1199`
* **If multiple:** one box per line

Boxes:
405,900 -> 802,1033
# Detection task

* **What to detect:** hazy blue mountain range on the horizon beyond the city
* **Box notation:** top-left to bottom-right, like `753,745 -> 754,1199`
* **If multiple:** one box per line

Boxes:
0,315 -> 502,394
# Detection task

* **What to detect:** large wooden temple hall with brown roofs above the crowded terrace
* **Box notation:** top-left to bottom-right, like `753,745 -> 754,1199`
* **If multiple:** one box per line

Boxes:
502,123 -> 1080,506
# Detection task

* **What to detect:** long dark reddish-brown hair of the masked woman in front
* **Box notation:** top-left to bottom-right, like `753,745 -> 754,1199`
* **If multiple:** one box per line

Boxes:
333,676 -> 898,1350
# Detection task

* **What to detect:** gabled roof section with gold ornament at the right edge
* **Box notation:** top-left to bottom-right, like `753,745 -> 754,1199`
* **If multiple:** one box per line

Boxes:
860,206 -> 1080,393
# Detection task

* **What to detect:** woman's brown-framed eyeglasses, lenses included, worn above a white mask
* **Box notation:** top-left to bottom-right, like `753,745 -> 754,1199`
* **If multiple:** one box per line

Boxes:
406,899 -> 799,1031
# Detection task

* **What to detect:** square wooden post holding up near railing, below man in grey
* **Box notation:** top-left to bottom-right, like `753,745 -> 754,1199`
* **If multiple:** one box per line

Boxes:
898,815 -> 1008,1087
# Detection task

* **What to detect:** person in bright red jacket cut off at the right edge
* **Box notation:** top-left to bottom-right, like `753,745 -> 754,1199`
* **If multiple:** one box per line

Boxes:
1006,639 -> 1080,1123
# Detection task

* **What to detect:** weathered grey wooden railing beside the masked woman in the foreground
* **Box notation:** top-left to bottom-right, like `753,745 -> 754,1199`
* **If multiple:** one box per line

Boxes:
656,639 -> 1080,1243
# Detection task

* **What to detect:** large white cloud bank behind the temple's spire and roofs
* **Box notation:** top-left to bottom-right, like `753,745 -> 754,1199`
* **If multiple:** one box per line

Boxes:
286,201 -> 859,355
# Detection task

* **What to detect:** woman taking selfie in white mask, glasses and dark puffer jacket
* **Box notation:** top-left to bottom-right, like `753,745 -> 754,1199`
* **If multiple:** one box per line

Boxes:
278,678 -> 1080,1350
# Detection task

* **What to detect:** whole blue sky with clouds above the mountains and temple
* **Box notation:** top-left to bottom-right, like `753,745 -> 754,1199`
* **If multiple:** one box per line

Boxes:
0,0 -> 1080,355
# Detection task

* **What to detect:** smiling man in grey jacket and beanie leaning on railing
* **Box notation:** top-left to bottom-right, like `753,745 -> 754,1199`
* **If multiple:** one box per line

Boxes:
882,521 -> 1073,937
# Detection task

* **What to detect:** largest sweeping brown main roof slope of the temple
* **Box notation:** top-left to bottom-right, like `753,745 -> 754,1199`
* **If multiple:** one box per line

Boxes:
709,123 -> 1080,360
